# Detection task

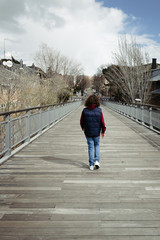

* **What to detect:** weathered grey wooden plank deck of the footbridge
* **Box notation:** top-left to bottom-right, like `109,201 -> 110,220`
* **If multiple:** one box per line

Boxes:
0,107 -> 160,240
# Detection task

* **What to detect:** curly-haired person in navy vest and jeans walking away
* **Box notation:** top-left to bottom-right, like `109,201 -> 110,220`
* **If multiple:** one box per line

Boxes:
80,95 -> 106,170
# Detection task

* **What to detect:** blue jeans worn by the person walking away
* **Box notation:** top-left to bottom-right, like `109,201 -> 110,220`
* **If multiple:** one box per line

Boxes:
86,137 -> 100,166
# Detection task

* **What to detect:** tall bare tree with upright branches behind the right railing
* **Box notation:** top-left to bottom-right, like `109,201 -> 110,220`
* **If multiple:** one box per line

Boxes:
103,37 -> 151,104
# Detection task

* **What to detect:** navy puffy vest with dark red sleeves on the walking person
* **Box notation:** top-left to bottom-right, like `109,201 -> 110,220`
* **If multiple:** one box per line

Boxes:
80,104 -> 106,137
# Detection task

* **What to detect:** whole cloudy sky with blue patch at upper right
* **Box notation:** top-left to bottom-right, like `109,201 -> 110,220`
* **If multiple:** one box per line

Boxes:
0,0 -> 160,76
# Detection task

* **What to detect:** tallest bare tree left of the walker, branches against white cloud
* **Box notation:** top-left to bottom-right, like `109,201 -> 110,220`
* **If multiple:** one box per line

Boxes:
35,43 -> 82,101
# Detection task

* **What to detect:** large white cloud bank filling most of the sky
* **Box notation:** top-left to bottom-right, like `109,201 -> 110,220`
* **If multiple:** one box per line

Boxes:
0,0 -> 159,74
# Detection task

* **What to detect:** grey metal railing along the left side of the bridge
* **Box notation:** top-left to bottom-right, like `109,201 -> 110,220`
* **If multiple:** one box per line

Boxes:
0,101 -> 82,164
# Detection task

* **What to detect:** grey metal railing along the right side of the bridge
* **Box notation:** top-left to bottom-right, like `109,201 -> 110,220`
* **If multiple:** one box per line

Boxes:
101,99 -> 160,133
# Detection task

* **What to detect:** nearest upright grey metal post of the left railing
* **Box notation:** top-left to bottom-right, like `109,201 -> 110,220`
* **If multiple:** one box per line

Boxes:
5,114 -> 11,156
